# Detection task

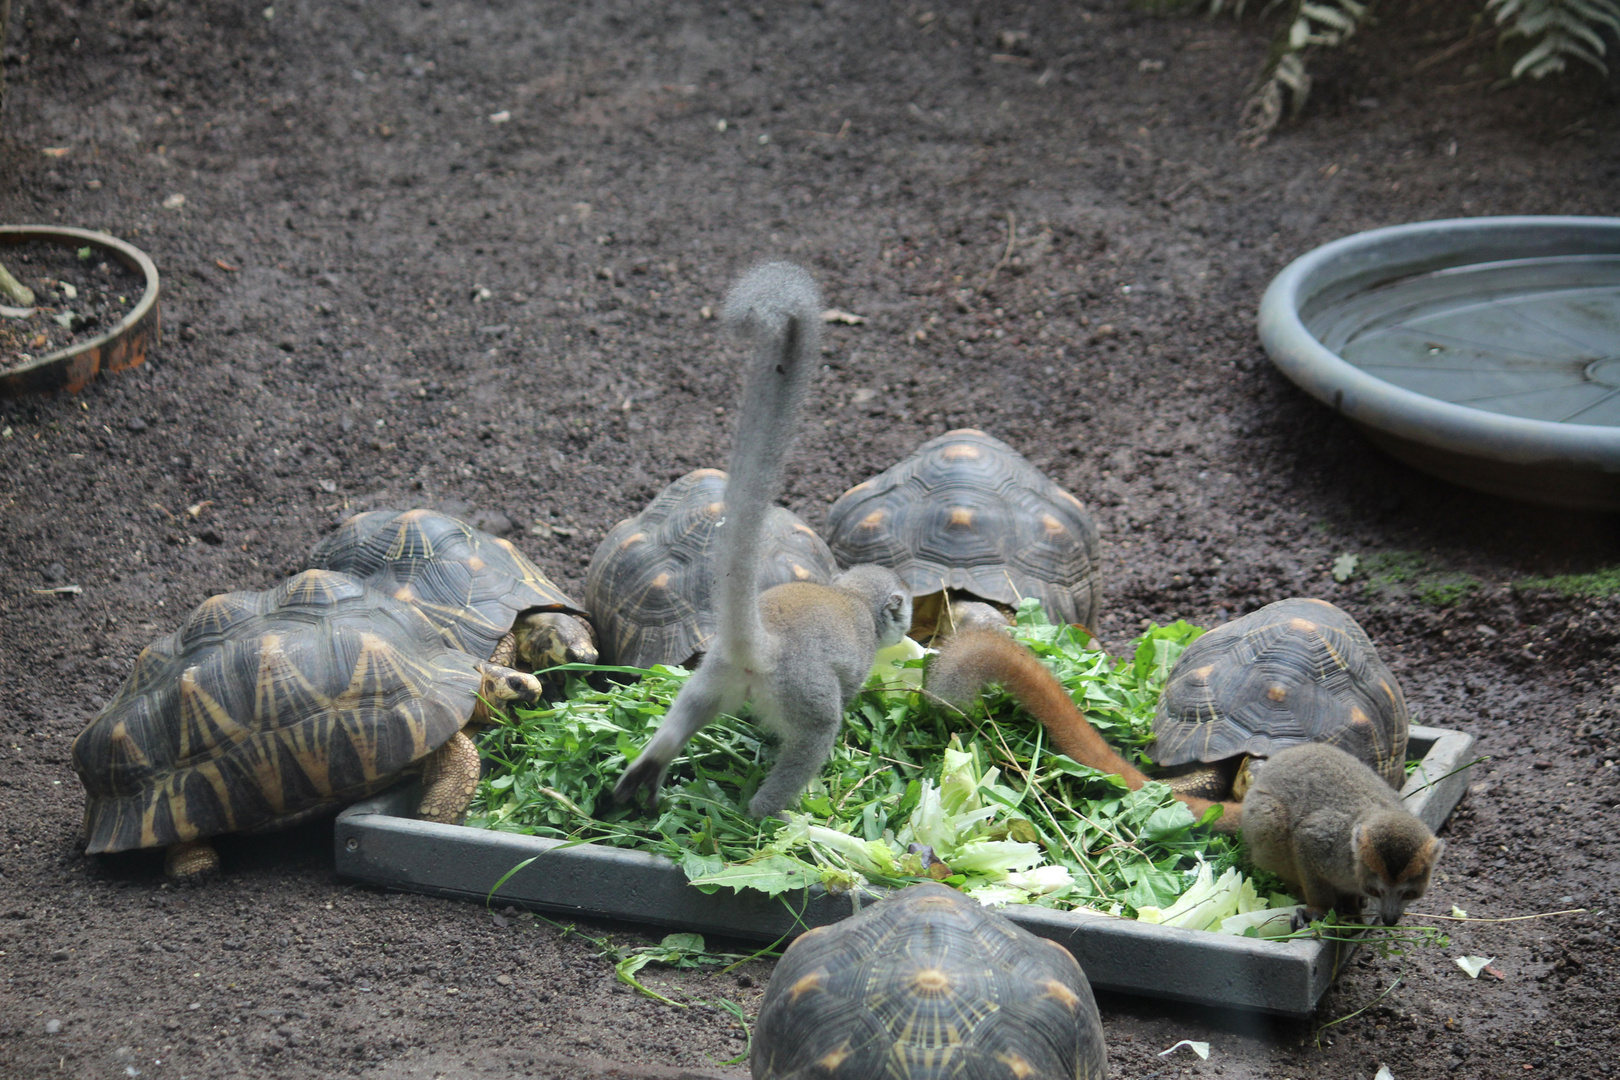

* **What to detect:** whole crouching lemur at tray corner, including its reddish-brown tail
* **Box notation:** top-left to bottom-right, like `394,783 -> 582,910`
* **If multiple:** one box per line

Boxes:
925,630 -> 1445,928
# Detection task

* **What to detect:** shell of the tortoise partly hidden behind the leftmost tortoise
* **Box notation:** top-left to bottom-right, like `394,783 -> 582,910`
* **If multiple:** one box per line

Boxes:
308,510 -> 585,657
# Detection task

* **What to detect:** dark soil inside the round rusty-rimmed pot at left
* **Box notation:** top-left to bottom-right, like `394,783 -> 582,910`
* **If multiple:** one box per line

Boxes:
0,240 -> 146,371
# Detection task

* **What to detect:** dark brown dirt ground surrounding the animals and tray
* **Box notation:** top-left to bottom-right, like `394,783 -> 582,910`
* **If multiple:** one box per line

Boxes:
0,0 -> 1620,1080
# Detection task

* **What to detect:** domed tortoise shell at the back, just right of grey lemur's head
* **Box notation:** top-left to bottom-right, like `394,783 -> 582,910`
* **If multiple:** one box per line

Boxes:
826,429 -> 1100,627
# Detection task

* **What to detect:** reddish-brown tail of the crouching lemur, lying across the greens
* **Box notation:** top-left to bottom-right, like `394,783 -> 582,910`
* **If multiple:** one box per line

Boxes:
925,630 -> 1243,832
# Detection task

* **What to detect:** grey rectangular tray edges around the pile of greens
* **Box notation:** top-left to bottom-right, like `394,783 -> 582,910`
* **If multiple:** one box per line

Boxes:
334,727 -> 1474,1017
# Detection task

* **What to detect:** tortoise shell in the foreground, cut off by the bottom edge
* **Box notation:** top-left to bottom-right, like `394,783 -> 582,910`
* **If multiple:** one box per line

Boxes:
748,882 -> 1108,1080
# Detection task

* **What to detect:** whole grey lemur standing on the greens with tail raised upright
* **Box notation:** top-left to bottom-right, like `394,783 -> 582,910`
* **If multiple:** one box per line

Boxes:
614,262 -> 910,818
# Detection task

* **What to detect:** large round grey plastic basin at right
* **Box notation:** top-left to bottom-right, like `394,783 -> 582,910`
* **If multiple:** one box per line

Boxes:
1260,217 -> 1620,510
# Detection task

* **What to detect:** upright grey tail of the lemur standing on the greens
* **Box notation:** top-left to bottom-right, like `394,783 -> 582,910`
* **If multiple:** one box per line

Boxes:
714,262 -> 821,661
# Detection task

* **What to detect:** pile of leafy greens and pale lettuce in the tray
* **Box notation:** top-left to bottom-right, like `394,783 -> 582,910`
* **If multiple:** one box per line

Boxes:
468,602 -> 1293,936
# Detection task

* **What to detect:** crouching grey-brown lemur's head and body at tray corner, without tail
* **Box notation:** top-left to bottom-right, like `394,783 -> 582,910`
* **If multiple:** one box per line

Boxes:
1243,743 -> 1445,929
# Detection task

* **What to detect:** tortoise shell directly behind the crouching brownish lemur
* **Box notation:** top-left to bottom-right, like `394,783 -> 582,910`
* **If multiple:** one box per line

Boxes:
1149,597 -> 1411,789
